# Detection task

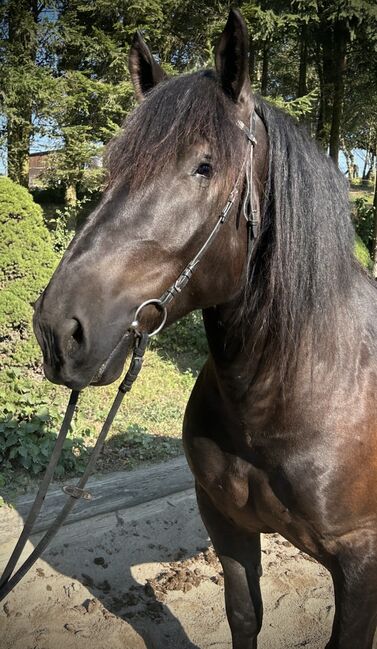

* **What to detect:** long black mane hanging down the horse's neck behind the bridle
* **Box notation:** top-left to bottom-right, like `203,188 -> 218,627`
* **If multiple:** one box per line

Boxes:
243,99 -> 357,376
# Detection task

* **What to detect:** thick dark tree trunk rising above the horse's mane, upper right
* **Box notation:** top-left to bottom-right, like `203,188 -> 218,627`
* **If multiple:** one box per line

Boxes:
330,22 -> 348,165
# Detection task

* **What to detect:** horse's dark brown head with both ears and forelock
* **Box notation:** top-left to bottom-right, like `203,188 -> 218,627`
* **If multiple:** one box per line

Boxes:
34,10 -> 266,389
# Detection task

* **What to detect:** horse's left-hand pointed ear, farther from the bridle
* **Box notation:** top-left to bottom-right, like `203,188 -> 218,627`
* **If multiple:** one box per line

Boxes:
128,32 -> 167,101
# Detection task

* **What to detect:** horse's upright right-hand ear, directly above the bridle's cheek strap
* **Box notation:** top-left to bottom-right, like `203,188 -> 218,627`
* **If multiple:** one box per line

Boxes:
215,9 -> 251,105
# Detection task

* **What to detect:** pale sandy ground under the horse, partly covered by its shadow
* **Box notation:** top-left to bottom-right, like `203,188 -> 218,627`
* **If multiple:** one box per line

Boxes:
0,489 -> 376,649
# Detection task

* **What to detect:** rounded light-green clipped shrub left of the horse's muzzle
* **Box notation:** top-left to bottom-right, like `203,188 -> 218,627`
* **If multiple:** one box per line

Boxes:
0,177 -> 58,367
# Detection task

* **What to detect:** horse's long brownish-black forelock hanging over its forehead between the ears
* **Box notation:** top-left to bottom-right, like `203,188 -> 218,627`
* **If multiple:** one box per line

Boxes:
106,70 -> 245,189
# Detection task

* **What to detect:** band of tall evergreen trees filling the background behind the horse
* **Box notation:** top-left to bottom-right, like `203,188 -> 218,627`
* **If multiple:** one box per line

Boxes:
0,0 -> 377,189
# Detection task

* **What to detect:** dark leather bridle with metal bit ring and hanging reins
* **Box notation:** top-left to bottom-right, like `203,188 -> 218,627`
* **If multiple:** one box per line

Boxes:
0,110 -> 259,601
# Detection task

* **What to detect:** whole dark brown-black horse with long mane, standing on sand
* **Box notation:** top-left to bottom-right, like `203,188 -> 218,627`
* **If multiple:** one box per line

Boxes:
35,11 -> 377,649
